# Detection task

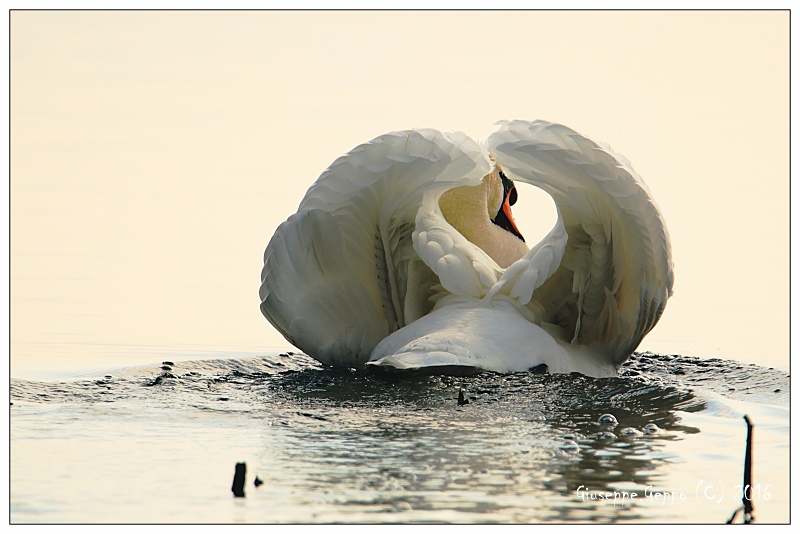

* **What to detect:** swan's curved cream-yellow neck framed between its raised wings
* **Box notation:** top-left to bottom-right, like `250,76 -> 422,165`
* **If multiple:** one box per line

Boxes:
439,168 -> 528,268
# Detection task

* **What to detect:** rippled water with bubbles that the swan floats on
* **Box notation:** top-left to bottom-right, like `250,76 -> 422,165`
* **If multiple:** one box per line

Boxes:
10,353 -> 789,523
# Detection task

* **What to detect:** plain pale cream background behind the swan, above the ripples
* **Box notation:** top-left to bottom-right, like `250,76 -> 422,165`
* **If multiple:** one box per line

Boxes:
10,11 -> 790,377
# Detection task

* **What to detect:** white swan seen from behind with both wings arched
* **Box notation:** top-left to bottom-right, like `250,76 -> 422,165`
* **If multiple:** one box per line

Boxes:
259,121 -> 673,382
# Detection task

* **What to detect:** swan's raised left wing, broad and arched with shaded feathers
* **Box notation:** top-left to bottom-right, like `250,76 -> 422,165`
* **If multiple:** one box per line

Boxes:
259,130 -> 490,365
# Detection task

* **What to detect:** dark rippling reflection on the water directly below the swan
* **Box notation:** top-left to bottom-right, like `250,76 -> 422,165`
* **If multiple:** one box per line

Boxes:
265,369 -> 703,520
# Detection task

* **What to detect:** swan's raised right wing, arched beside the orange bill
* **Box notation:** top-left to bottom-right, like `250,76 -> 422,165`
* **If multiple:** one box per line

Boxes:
488,121 -> 673,363
